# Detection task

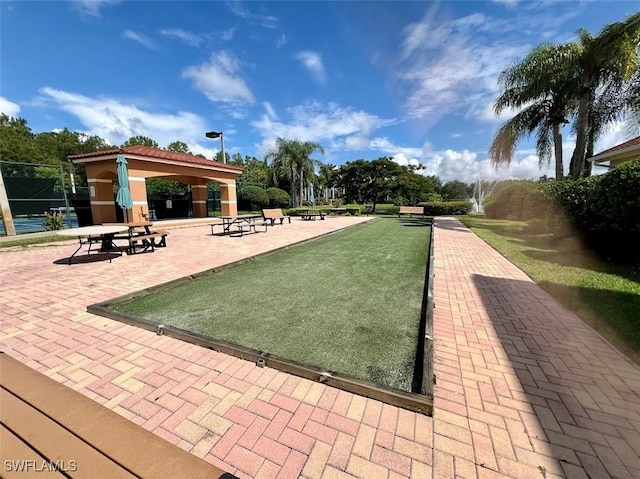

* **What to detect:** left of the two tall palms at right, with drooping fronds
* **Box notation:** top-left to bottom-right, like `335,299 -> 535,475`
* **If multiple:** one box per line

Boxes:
489,44 -> 577,178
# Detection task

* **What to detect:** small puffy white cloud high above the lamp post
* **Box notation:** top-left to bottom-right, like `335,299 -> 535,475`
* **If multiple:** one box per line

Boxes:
182,51 -> 255,110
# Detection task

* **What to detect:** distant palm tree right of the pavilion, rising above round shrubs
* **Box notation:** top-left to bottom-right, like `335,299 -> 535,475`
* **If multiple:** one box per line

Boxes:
265,138 -> 324,206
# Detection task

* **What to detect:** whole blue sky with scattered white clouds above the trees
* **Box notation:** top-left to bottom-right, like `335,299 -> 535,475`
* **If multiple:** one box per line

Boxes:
0,0 -> 637,182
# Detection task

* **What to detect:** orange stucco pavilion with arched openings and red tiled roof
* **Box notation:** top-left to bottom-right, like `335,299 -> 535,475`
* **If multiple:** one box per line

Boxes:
67,145 -> 243,224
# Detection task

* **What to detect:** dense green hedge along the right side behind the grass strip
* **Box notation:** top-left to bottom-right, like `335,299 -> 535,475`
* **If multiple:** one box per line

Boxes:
484,158 -> 640,264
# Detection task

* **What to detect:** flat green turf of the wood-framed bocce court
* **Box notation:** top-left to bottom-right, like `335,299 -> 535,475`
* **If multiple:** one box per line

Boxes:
116,218 -> 430,392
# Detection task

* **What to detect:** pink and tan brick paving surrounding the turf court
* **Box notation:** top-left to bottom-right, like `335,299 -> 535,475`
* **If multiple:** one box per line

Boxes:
0,218 -> 640,479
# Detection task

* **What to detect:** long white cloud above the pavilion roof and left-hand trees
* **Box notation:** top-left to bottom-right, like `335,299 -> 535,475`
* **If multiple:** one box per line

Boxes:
40,87 -> 206,151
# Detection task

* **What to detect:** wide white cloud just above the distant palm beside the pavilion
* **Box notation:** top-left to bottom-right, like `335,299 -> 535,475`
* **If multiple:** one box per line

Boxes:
251,101 -> 397,154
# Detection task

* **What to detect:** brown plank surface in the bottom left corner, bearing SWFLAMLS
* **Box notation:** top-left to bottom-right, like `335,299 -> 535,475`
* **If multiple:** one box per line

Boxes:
0,352 -> 236,479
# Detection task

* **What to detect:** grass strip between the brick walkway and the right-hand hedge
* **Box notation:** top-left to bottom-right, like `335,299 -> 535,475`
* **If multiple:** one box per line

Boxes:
459,216 -> 640,364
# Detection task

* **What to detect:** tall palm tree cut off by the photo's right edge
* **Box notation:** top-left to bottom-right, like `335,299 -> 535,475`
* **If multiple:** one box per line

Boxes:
563,12 -> 640,179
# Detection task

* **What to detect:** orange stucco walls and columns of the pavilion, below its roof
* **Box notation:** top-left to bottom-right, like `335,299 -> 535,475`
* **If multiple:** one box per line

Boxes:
81,155 -> 238,224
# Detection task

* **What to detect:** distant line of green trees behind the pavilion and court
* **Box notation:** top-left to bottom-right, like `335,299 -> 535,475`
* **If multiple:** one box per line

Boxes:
0,114 -> 480,206
